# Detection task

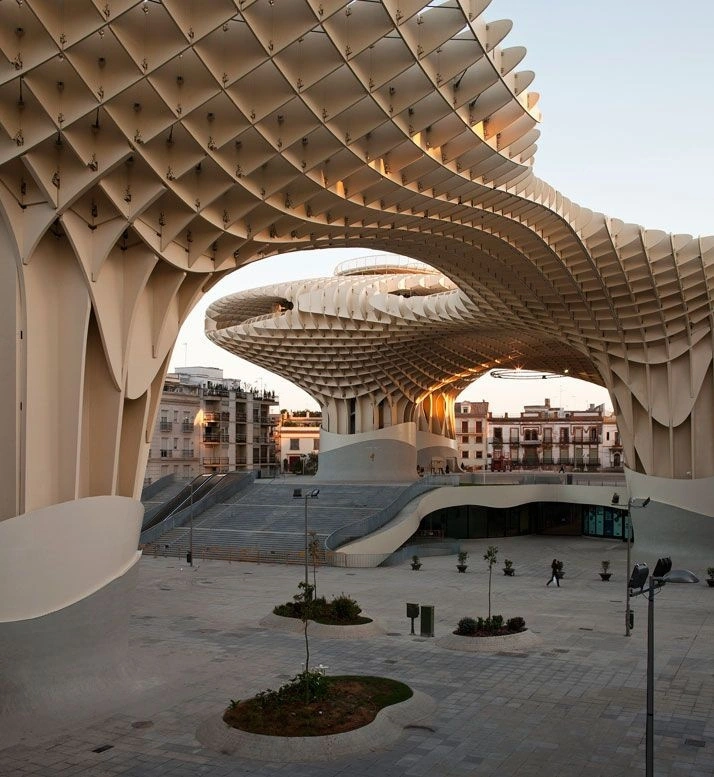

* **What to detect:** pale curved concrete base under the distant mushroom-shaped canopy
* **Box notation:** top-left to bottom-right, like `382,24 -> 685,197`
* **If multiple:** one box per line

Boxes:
318,423 -> 417,483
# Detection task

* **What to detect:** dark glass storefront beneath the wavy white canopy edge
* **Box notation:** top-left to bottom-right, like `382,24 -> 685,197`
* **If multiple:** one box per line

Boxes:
419,502 -> 624,539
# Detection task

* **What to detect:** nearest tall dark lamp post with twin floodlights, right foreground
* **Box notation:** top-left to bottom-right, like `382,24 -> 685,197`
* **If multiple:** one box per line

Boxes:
628,558 -> 699,777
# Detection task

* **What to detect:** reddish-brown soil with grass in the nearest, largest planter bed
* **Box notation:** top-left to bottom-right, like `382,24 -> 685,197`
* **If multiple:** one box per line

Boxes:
223,675 -> 412,737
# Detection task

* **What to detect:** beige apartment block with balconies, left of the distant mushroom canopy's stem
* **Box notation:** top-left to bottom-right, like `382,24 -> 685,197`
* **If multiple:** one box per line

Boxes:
145,367 -> 280,483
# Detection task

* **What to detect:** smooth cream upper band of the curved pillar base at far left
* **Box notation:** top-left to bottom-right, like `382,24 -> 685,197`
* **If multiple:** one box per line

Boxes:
0,496 -> 144,623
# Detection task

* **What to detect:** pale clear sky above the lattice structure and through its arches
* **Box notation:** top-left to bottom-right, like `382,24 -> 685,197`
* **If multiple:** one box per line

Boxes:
172,0 -> 714,412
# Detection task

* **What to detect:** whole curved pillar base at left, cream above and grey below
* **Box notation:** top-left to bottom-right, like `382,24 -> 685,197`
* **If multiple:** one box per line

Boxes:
0,496 -> 144,725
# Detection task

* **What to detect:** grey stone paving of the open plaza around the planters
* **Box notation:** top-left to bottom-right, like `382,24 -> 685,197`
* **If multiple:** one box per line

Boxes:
0,537 -> 714,777
